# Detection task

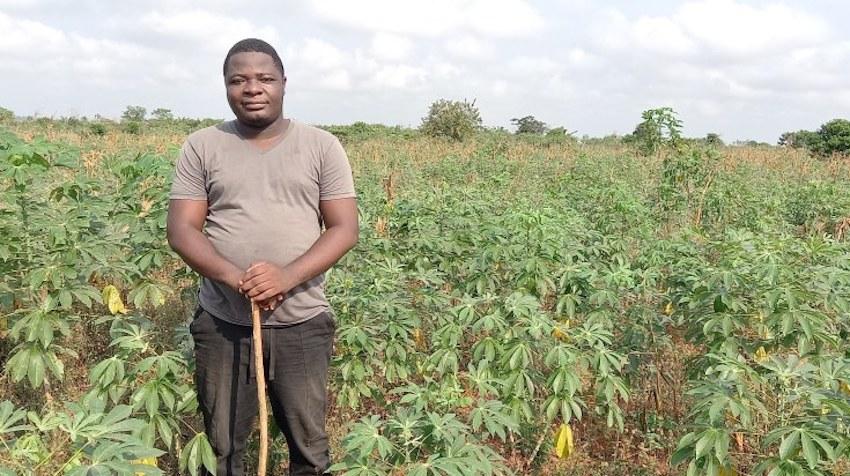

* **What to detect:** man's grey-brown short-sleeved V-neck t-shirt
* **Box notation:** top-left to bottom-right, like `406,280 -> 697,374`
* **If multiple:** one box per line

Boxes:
169,121 -> 355,327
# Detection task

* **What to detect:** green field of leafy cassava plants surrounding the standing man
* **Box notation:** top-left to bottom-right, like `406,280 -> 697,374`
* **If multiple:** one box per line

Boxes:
0,121 -> 850,476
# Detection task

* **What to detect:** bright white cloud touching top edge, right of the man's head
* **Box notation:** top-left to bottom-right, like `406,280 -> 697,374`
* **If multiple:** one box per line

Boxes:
311,0 -> 545,38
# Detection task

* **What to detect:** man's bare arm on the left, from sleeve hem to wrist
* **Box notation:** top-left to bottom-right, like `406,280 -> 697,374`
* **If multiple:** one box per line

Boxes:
166,200 -> 244,289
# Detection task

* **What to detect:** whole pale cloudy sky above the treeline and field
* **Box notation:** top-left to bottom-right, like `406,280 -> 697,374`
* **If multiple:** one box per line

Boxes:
0,0 -> 850,142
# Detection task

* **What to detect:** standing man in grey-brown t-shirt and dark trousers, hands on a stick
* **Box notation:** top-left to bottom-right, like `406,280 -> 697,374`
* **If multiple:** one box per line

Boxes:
168,39 -> 358,476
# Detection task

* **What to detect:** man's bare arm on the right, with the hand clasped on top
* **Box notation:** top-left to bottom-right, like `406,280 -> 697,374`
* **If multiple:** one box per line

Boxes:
239,198 -> 360,301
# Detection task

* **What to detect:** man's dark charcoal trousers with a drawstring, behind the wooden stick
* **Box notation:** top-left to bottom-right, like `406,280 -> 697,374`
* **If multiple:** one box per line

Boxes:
189,309 -> 335,476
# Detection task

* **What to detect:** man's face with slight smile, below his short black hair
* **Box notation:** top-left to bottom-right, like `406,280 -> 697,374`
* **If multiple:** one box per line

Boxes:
224,52 -> 286,128
